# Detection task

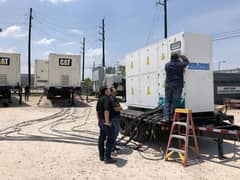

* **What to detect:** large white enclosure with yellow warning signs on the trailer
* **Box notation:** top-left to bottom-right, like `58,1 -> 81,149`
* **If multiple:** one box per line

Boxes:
125,32 -> 214,112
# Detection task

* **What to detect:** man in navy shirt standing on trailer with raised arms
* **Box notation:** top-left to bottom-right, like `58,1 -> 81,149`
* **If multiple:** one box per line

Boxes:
164,53 -> 189,121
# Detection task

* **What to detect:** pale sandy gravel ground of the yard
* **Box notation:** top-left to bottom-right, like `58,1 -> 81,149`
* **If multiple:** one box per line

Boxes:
0,97 -> 240,180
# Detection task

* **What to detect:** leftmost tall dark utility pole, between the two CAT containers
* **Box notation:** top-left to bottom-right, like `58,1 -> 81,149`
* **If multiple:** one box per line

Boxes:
28,8 -> 32,89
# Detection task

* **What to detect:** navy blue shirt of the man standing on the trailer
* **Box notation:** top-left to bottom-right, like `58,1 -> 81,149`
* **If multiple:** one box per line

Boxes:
165,57 -> 189,88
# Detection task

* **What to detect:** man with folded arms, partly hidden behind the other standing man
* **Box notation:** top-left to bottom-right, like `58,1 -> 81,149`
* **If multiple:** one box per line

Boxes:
111,88 -> 122,155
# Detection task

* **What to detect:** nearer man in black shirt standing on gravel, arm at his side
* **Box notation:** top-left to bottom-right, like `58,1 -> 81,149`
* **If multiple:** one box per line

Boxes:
96,87 -> 116,163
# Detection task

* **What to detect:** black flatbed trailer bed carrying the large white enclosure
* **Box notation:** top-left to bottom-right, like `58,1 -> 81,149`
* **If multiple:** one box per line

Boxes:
121,108 -> 240,158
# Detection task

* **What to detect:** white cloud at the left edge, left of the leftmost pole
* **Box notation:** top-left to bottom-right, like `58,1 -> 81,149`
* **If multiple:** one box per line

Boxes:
0,25 -> 27,39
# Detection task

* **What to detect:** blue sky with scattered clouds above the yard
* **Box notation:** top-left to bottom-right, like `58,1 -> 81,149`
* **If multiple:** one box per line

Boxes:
0,0 -> 240,76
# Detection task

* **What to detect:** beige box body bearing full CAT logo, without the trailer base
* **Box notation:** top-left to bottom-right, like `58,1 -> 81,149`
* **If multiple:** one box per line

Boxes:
48,54 -> 81,88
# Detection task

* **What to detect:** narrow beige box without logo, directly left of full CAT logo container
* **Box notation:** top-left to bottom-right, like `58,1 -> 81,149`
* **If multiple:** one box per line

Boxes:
35,60 -> 48,87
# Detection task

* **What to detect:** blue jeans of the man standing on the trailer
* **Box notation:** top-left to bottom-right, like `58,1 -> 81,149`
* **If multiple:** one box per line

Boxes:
164,87 -> 182,120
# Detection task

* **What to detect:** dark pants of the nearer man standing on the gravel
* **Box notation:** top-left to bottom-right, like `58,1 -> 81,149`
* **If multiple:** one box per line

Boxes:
98,120 -> 114,160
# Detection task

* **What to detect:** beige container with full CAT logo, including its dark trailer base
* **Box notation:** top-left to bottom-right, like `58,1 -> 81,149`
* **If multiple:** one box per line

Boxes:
47,54 -> 81,99
